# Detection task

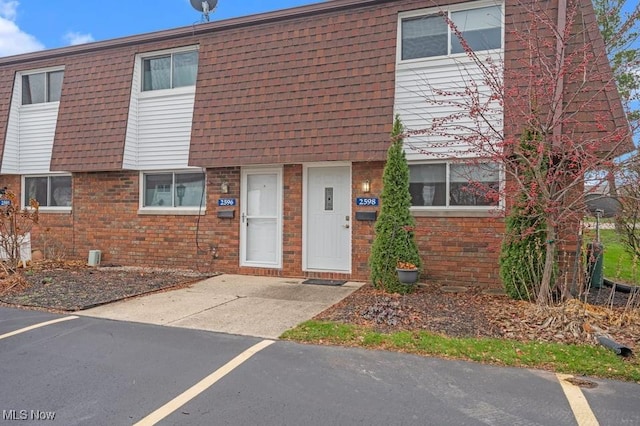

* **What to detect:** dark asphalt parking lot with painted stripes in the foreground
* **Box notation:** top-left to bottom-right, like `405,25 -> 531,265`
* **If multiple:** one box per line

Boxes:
0,308 -> 640,425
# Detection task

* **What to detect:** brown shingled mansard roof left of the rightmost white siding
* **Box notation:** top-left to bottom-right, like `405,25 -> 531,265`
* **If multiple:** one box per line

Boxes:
0,0 -> 625,172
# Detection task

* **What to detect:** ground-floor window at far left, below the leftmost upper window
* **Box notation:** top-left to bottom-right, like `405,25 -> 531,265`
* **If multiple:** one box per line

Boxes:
22,176 -> 72,207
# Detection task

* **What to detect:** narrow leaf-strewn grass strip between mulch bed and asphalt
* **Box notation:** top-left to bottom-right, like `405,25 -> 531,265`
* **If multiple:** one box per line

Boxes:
281,320 -> 640,382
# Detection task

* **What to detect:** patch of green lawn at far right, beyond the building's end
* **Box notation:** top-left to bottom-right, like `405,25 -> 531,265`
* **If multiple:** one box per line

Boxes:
584,229 -> 640,284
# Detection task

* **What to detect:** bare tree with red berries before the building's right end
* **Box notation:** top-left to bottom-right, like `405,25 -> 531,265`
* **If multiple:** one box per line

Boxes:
400,0 -> 632,305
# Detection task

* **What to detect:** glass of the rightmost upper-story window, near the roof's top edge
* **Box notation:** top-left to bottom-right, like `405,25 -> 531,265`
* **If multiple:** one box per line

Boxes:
400,6 -> 502,61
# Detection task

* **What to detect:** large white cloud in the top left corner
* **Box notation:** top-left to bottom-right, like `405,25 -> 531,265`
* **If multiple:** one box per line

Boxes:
0,0 -> 44,56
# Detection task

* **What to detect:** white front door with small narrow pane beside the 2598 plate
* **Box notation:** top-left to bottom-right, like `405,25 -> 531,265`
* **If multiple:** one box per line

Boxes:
305,166 -> 351,273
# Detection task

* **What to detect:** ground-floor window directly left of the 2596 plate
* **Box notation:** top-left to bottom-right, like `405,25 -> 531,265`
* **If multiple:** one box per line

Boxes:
143,172 -> 205,208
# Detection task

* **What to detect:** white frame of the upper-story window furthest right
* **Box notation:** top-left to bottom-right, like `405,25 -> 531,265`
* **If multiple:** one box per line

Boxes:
396,0 -> 505,65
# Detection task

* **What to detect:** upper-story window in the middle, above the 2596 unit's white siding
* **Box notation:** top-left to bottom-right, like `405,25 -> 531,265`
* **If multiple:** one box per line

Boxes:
142,50 -> 198,92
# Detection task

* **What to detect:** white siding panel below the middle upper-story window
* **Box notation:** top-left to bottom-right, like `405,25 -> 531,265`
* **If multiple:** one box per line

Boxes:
124,48 -> 195,170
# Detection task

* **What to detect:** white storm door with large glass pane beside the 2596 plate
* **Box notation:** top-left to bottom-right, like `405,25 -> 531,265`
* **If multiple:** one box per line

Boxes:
240,169 -> 282,268
